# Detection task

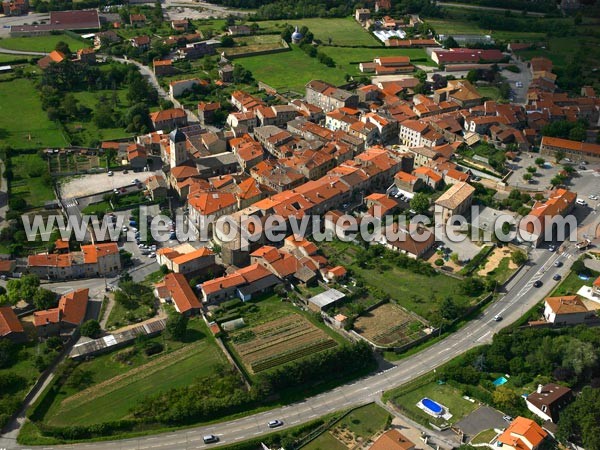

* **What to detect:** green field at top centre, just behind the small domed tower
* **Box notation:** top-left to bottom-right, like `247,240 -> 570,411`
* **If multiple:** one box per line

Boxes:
257,17 -> 383,46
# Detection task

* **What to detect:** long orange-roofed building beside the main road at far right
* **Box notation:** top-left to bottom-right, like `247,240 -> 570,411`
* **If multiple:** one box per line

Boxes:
519,188 -> 577,245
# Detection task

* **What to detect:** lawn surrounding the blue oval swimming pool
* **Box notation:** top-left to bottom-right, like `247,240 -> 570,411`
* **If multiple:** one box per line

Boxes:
391,381 -> 477,424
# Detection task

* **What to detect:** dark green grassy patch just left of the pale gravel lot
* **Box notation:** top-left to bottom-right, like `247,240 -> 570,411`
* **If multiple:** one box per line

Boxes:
10,153 -> 54,208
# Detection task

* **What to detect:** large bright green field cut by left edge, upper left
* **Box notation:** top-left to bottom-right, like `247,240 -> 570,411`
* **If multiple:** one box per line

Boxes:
0,78 -> 67,149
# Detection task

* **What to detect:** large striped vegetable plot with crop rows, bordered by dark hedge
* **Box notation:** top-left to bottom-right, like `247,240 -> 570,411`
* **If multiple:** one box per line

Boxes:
231,314 -> 337,373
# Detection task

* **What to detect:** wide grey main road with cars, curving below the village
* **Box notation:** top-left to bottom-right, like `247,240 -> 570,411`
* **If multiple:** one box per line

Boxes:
0,234 -> 592,450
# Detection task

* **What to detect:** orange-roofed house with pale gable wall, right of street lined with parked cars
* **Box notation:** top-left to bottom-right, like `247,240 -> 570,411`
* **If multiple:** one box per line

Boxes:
156,244 -> 215,276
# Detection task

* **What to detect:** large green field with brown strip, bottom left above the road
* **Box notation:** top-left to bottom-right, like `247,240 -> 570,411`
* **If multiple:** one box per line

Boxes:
45,319 -> 225,426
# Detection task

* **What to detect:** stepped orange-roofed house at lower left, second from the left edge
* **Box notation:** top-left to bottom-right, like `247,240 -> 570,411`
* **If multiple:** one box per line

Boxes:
33,288 -> 89,337
